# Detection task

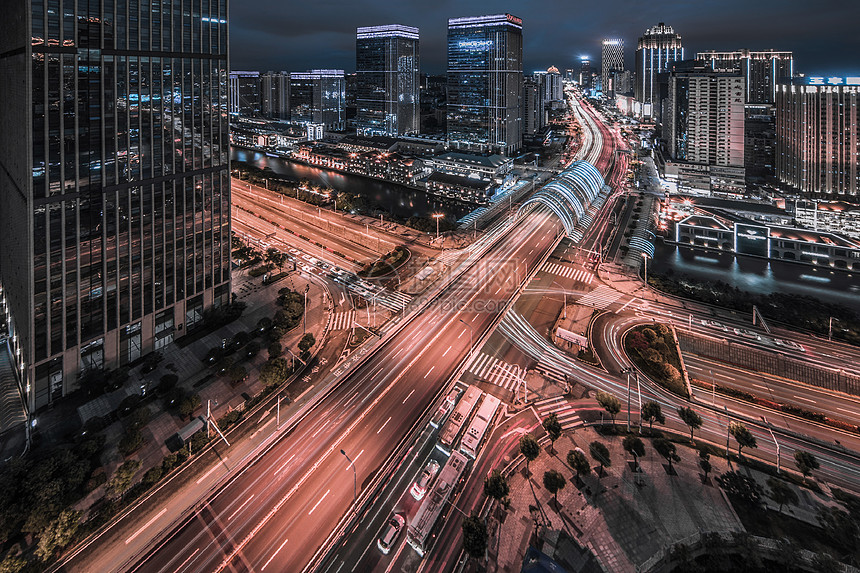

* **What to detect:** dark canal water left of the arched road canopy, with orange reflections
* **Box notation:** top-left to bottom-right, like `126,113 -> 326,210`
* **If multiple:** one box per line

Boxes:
230,147 -> 478,219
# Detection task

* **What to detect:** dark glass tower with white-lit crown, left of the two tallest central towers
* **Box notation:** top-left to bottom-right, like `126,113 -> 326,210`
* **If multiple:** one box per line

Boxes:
355,24 -> 420,135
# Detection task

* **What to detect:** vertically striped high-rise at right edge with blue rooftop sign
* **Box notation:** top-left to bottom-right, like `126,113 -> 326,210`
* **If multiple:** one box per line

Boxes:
776,76 -> 860,196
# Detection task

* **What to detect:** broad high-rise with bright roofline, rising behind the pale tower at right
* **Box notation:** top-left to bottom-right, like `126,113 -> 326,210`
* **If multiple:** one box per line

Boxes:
696,50 -> 794,103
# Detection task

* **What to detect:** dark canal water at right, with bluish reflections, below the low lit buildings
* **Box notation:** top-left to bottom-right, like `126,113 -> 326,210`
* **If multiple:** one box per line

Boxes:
648,241 -> 860,314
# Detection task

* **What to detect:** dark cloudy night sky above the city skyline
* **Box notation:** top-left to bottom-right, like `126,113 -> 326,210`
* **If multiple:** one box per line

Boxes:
230,0 -> 860,76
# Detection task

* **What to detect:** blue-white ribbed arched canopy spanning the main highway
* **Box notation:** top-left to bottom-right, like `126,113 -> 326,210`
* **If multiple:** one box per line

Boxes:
517,161 -> 605,237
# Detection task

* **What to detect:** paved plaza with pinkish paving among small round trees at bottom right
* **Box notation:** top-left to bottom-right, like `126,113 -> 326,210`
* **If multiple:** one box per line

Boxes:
488,428 -> 743,573
